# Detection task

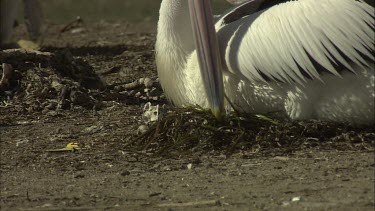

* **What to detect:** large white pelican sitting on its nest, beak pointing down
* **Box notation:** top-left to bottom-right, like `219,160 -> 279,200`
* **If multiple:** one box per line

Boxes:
155,0 -> 375,124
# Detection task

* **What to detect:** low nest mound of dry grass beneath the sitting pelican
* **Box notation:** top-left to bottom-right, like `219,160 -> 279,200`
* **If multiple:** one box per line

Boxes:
129,107 -> 375,156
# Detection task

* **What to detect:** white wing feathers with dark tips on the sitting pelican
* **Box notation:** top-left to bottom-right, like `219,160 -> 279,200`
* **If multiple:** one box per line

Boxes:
217,0 -> 375,83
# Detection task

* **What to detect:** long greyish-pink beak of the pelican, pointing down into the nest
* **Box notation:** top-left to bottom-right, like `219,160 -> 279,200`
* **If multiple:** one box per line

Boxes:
188,0 -> 224,119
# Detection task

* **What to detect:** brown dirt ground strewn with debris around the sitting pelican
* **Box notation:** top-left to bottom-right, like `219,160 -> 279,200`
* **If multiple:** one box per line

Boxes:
0,21 -> 375,210
